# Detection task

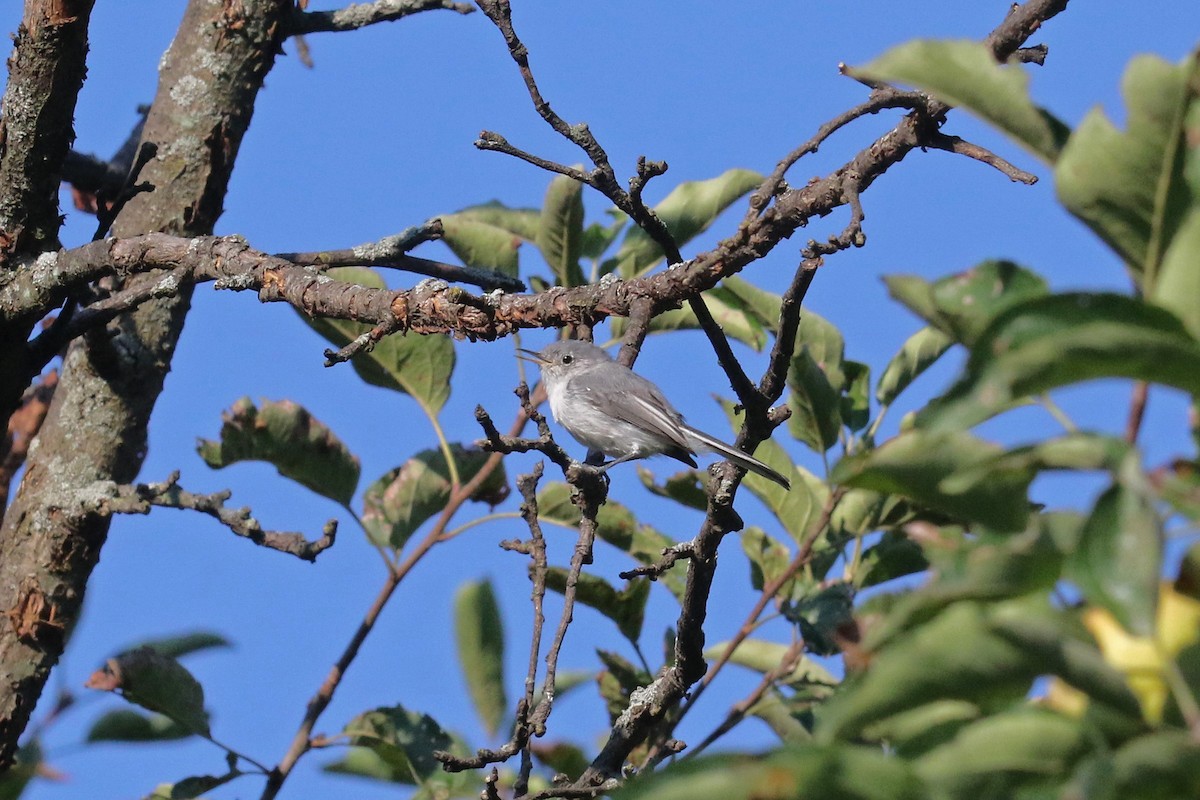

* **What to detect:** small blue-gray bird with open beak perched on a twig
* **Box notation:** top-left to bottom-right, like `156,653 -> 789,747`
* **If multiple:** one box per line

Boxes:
517,341 -> 791,488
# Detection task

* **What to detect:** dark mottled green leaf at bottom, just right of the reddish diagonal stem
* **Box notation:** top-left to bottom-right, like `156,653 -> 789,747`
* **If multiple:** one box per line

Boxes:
342,705 -> 452,783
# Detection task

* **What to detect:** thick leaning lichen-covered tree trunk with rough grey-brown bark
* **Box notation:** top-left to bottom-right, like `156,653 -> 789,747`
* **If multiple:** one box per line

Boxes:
0,0 -> 292,770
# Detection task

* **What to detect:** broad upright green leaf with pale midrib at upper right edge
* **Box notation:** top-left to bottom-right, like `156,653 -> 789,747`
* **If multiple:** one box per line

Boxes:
1055,55 -> 1195,286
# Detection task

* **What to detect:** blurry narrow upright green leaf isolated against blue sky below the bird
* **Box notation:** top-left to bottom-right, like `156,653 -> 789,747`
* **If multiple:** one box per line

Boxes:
454,581 -> 509,736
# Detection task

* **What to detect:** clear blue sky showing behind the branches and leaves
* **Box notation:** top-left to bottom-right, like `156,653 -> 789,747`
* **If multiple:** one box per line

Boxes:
9,0 -> 1200,800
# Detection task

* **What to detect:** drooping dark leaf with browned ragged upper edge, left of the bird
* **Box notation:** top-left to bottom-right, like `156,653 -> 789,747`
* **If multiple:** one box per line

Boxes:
197,397 -> 361,506
